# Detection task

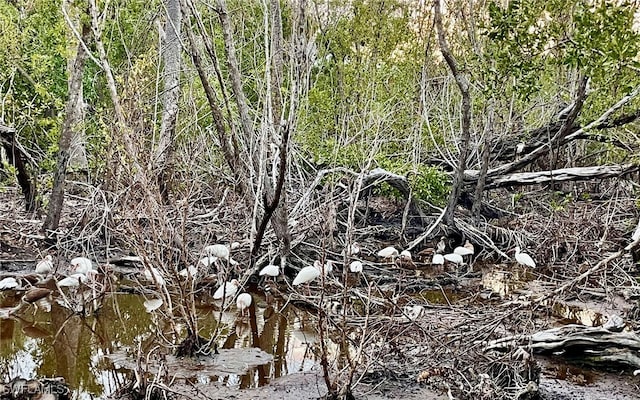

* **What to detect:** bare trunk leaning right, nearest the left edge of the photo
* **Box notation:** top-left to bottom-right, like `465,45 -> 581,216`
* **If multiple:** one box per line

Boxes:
42,17 -> 89,236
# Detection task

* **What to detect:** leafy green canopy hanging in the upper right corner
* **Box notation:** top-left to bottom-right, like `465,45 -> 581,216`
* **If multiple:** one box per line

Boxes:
483,0 -> 640,109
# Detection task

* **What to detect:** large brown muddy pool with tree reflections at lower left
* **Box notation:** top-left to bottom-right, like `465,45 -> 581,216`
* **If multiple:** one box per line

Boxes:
0,291 -> 317,399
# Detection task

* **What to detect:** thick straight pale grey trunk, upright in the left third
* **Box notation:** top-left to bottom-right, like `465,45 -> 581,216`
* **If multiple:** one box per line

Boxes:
155,0 -> 182,204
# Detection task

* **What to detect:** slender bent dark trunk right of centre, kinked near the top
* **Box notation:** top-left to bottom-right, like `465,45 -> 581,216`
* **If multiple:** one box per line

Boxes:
433,0 -> 471,226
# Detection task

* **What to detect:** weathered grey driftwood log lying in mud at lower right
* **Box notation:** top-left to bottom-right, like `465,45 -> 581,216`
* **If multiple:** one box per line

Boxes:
485,324 -> 640,368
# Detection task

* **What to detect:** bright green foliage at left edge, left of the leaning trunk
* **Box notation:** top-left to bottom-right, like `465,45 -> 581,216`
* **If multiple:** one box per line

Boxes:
0,0 -> 67,166
